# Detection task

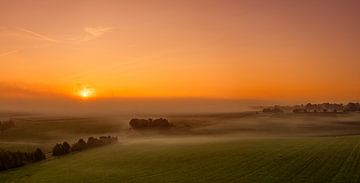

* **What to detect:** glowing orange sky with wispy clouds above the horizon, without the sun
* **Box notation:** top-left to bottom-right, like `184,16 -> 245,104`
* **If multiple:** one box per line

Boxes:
0,0 -> 360,100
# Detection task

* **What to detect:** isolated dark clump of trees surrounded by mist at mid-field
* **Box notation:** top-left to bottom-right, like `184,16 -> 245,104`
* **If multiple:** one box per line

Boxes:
129,118 -> 173,129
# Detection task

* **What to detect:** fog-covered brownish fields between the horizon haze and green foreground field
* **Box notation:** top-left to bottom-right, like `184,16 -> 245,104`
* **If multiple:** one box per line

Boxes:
0,106 -> 360,150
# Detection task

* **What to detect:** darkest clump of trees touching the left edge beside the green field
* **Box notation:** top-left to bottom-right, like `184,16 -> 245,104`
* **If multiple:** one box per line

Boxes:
0,148 -> 46,170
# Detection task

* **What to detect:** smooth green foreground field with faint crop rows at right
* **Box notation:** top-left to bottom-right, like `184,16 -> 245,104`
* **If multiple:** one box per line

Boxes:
0,136 -> 360,183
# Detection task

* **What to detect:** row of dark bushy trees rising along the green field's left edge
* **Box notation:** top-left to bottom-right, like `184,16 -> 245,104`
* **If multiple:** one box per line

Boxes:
52,136 -> 118,156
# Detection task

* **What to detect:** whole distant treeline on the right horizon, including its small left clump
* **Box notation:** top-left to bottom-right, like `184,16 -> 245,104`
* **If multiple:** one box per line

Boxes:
262,102 -> 360,113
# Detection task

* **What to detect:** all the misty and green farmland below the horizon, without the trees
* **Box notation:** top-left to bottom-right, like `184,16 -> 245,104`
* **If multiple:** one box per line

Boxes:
0,112 -> 360,183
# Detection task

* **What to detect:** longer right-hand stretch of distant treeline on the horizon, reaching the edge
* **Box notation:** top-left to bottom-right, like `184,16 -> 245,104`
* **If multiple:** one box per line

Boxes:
293,102 -> 360,113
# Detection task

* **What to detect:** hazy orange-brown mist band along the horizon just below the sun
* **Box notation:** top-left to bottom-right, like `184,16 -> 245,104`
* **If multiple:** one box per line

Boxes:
0,98 -> 285,115
